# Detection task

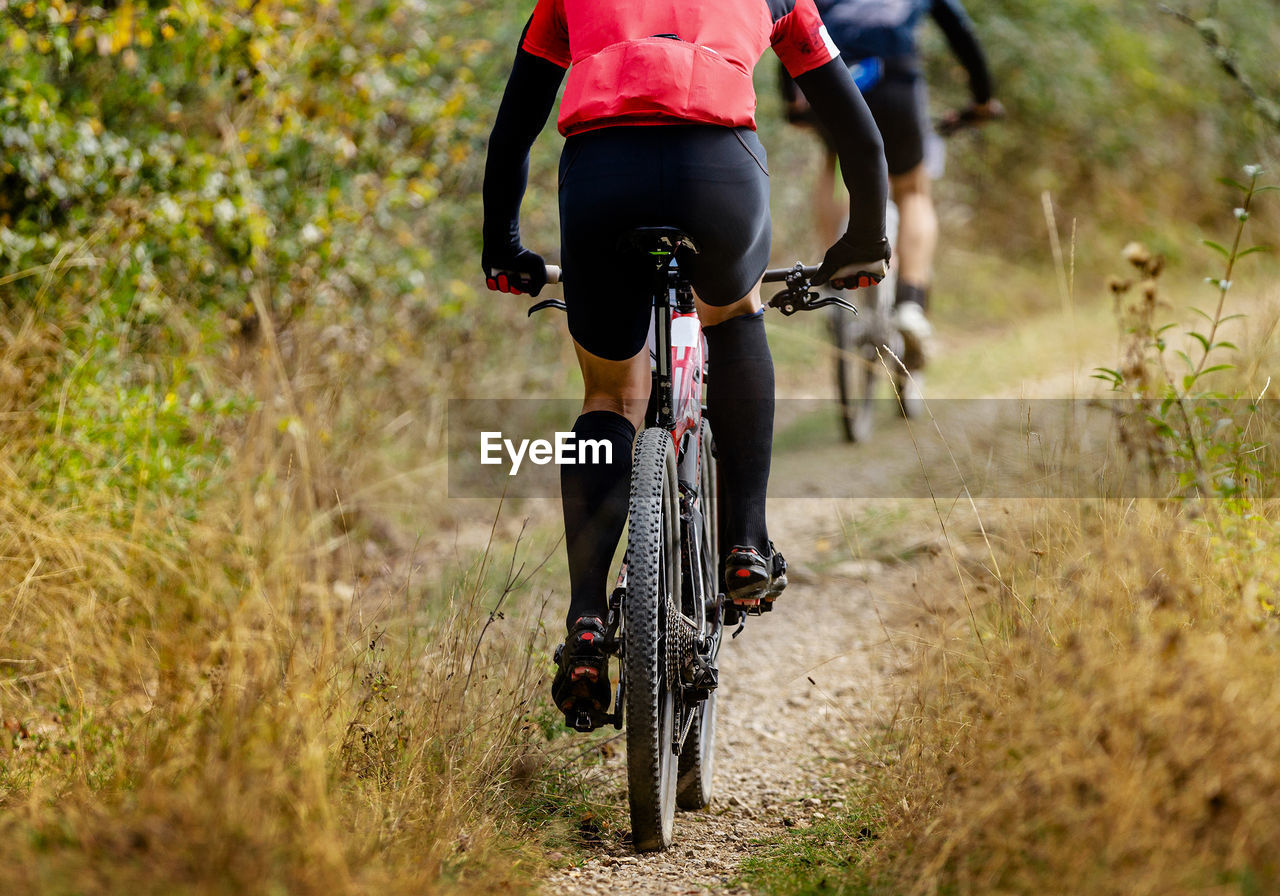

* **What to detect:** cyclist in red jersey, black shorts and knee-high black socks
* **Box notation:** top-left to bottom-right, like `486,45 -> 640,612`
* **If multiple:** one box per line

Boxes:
481,0 -> 890,716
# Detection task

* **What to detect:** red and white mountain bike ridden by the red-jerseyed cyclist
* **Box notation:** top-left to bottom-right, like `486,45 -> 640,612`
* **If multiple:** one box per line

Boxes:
529,234 -> 854,851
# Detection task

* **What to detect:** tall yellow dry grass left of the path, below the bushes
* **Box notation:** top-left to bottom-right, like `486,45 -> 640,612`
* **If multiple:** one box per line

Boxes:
0,294 -> 570,893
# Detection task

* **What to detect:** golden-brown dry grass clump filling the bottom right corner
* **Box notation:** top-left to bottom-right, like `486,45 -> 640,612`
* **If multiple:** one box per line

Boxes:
872,503 -> 1280,895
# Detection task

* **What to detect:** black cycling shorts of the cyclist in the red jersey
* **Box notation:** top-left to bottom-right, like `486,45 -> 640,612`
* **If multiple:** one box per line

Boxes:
559,124 -> 771,361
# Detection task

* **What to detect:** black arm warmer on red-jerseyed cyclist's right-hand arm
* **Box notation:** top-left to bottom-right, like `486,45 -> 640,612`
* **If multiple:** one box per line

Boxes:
796,59 -> 888,261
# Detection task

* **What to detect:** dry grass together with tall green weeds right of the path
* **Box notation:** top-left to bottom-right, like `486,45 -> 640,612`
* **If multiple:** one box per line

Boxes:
746,166 -> 1280,896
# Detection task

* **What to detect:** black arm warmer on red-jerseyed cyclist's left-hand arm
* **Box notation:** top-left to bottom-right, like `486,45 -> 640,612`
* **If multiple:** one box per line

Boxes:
483,42 -> 564,253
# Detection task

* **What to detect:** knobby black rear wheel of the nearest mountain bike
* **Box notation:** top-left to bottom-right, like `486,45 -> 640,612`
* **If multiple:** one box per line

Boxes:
622,428 -> 680,851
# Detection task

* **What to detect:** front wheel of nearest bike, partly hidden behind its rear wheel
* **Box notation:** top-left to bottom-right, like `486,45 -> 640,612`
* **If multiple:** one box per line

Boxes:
676,420 -> 723,810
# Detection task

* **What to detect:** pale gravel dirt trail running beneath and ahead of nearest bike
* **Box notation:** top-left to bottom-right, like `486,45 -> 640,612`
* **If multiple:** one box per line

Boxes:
544,335 -> 1095,896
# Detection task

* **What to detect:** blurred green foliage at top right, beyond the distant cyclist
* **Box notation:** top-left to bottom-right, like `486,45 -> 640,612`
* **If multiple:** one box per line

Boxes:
922,0 -> 1280,255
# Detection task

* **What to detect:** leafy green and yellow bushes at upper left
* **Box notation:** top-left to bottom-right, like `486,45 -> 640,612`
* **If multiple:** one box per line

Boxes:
0,0 -> 565,524
